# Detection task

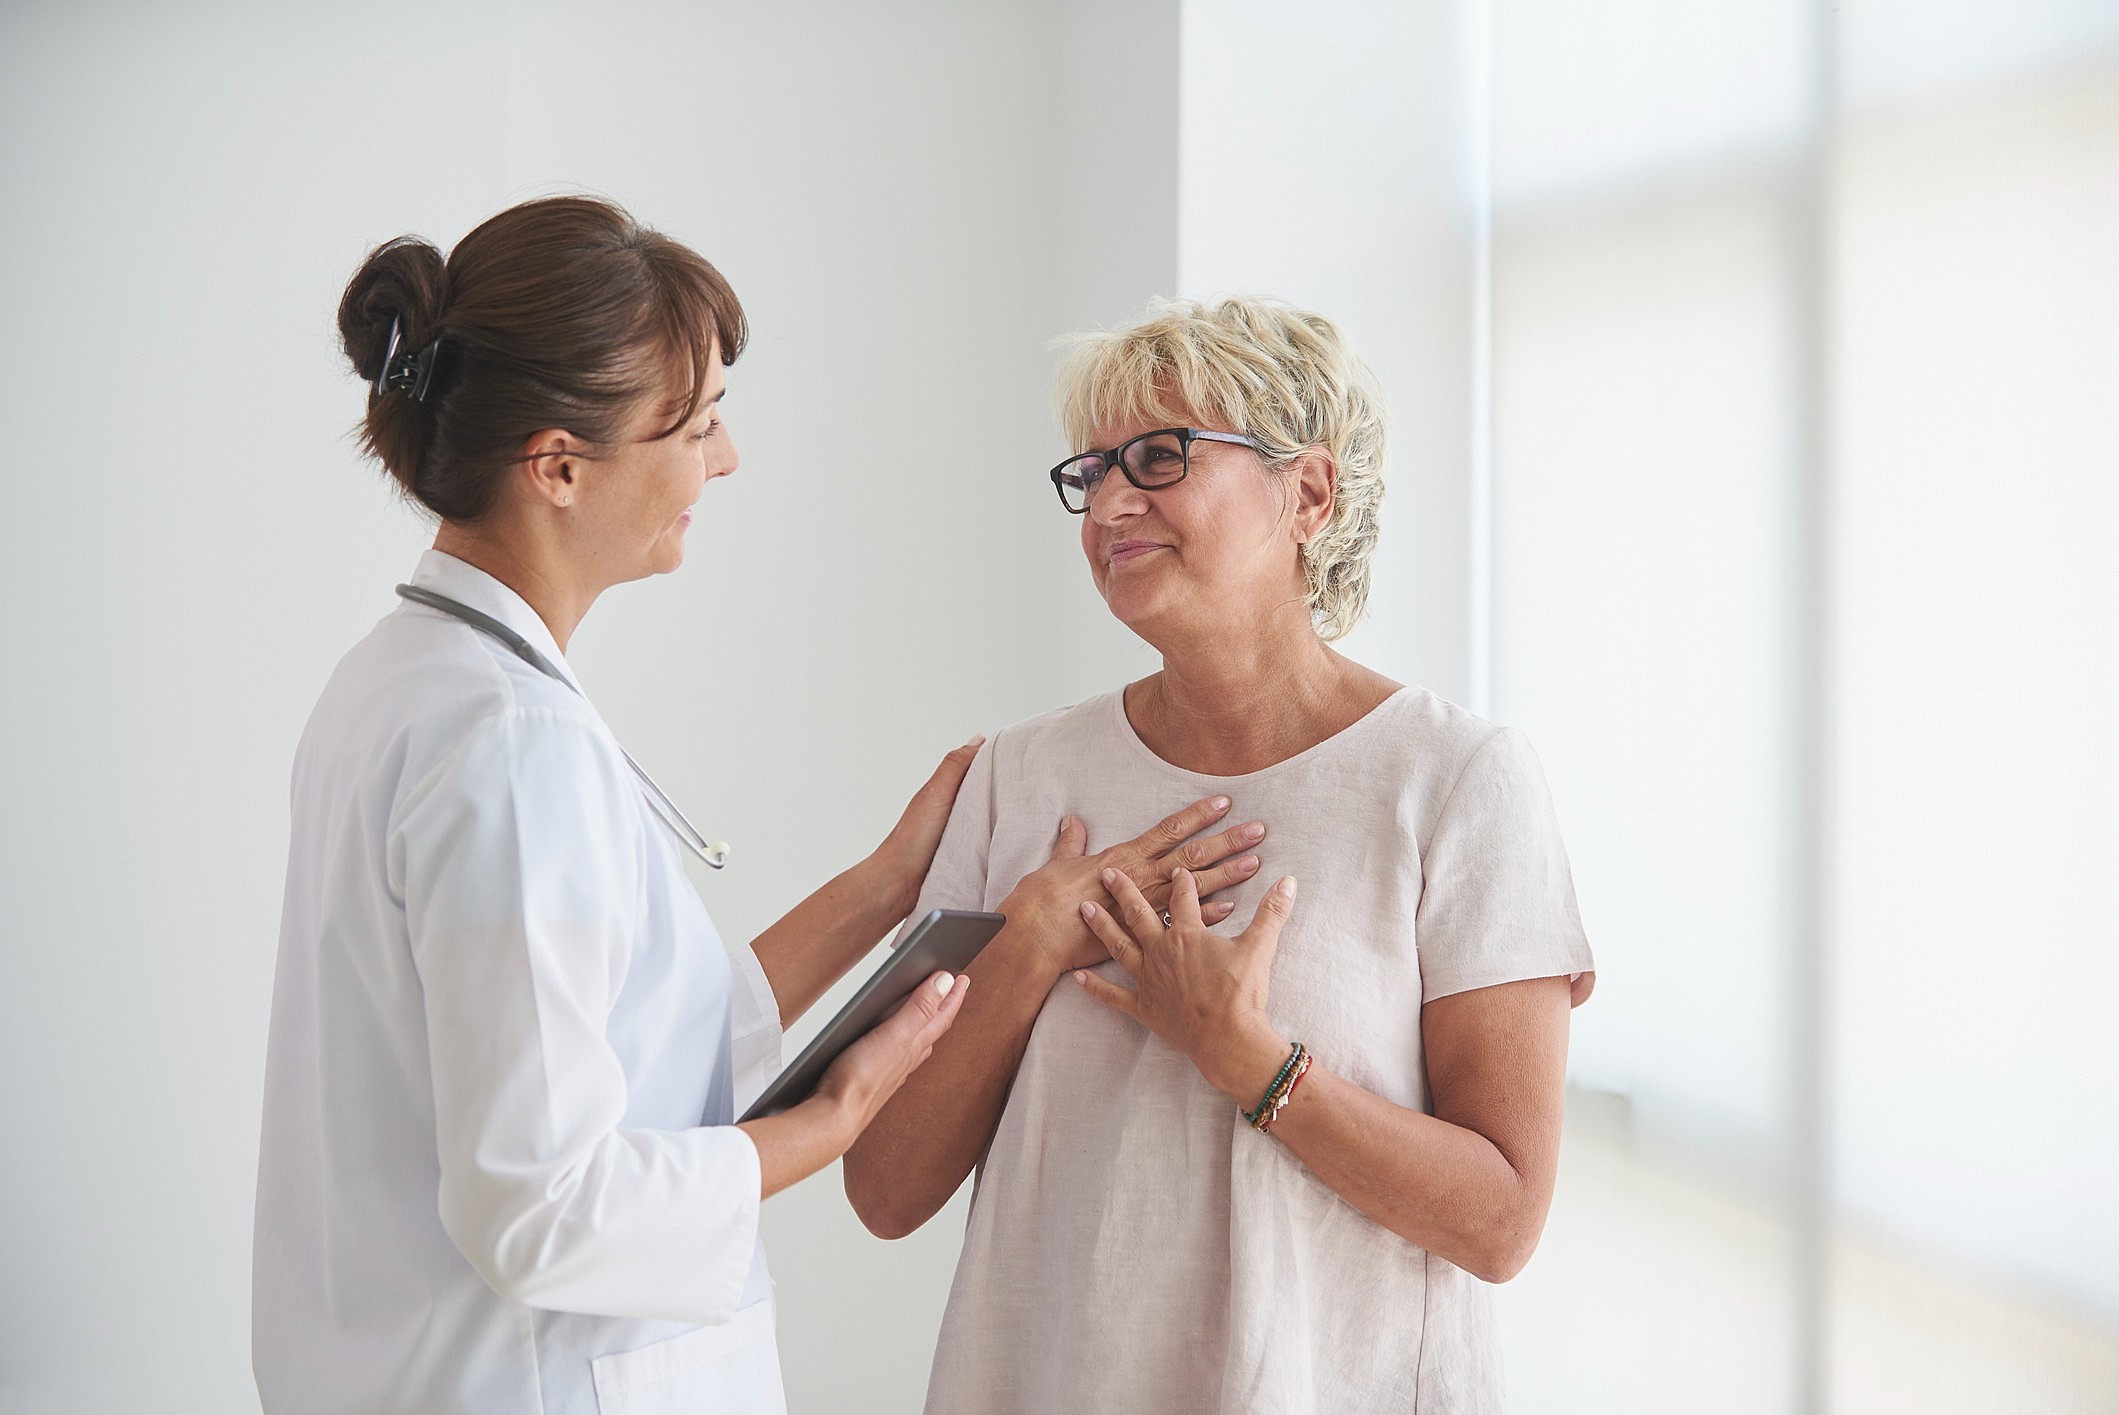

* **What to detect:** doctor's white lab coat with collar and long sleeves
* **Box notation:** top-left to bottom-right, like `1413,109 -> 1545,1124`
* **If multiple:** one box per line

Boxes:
252,551 -> 784,1415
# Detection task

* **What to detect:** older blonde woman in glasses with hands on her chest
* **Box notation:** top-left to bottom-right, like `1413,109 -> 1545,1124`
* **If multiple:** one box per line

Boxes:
845,299 -> 1593,1415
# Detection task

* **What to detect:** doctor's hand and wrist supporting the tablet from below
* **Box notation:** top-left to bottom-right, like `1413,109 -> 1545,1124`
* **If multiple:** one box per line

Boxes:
737,972 -> 971,1199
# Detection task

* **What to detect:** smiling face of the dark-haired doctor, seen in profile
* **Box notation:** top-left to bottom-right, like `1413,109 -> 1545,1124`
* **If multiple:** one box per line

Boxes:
574,358 -> 737,585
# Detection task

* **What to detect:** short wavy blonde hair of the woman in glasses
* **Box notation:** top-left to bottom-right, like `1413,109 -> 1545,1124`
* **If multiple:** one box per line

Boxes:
1053,297 -> 1388,640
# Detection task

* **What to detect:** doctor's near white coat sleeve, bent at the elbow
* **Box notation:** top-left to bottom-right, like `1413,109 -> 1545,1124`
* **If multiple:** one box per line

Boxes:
394,708 -> 759,1324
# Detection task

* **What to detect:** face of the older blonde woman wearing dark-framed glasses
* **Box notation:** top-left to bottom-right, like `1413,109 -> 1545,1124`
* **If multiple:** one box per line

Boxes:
1081,417 -> 1305,652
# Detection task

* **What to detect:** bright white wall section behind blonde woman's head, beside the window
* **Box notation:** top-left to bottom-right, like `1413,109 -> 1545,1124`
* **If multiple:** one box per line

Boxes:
1178,0 -> 1477,703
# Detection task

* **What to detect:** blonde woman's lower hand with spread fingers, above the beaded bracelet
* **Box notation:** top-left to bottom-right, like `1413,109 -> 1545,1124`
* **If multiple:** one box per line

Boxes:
1074,871 -> 1295,1106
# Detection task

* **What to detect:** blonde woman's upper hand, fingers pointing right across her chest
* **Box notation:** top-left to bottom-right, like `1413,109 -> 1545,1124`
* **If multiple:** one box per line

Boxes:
1000,796 -> 1265,977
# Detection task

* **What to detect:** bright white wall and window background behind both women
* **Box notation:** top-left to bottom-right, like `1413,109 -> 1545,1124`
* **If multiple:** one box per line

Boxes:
0,0 -> 2119,1415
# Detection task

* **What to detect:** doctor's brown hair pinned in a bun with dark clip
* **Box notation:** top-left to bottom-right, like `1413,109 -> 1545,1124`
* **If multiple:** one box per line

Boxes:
339,197 -> 750,521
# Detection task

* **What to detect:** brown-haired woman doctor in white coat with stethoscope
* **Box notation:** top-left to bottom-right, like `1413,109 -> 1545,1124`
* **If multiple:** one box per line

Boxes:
252,199 -> 975,1415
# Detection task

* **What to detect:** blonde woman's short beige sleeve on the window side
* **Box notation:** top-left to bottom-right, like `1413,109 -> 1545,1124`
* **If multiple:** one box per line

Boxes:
1415,729 -> 1596,1002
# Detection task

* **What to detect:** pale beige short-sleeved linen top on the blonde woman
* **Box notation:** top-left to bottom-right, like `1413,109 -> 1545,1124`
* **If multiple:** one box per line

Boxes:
913,688 -> 1593,1415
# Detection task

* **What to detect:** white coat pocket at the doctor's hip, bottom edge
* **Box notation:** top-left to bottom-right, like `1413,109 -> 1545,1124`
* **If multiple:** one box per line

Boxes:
589,1298 -> 786,1415
